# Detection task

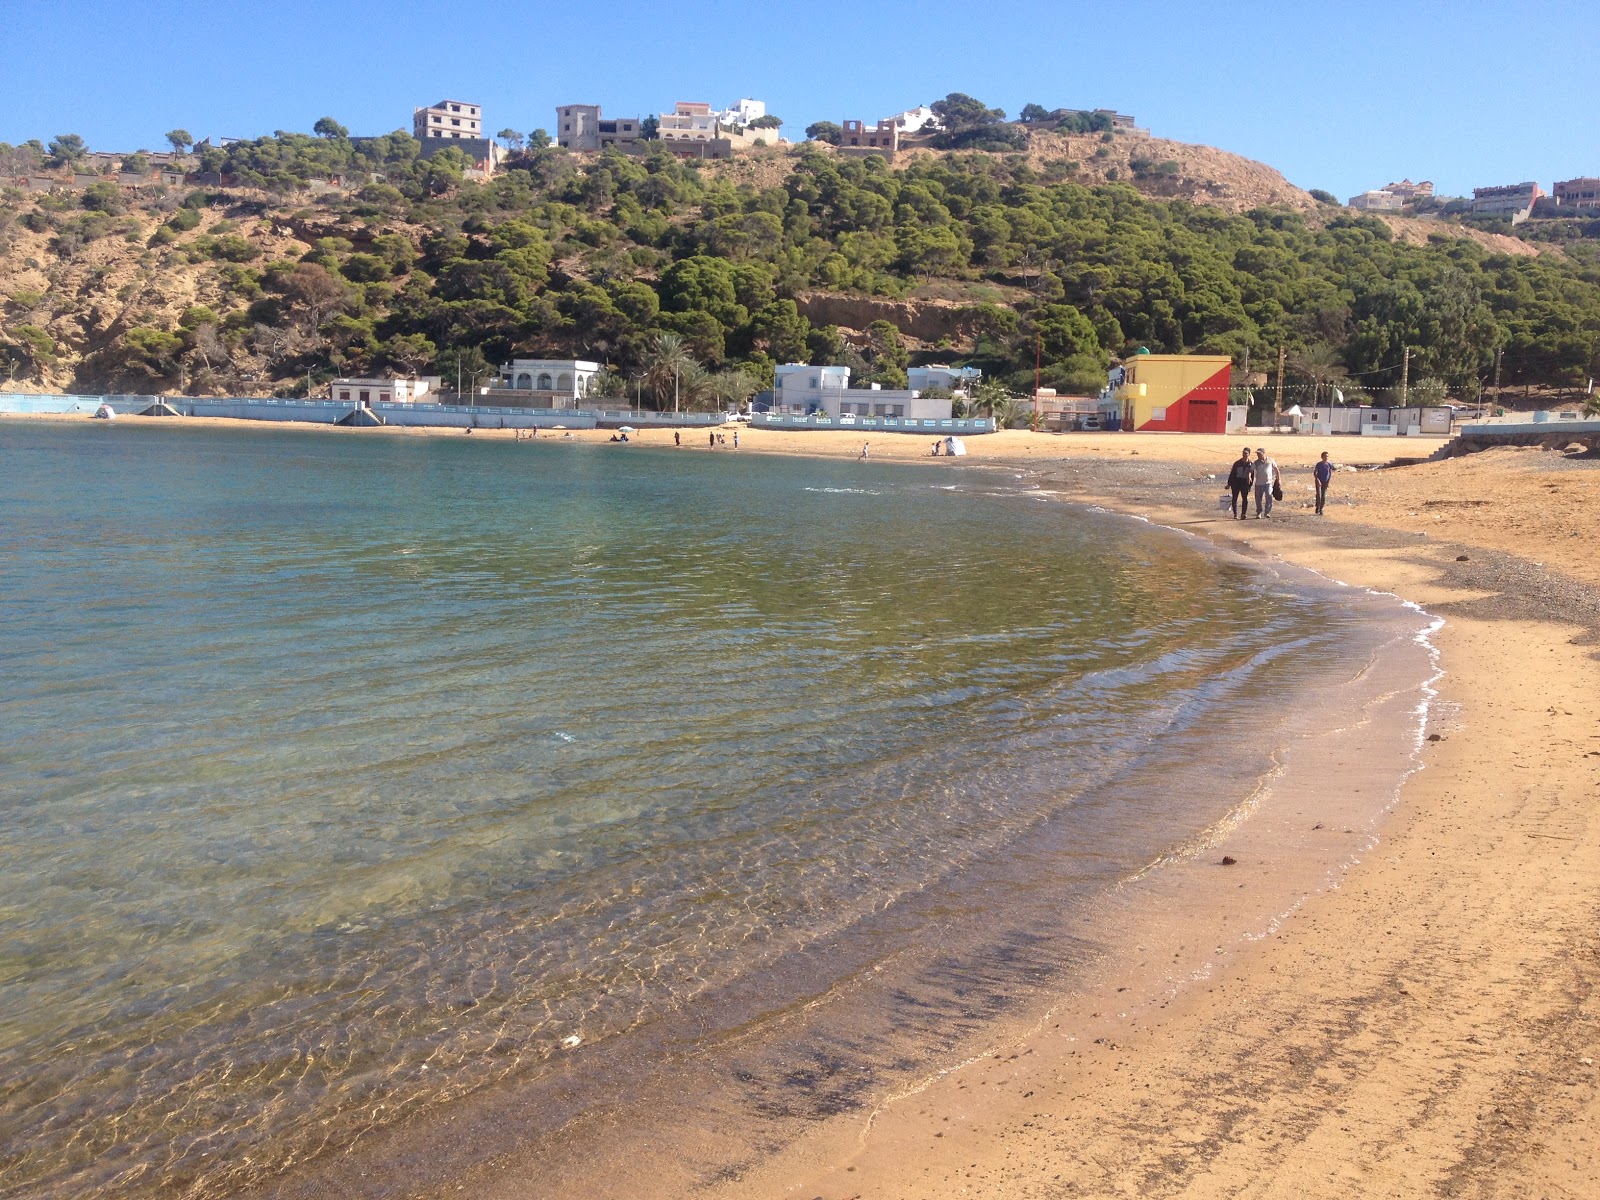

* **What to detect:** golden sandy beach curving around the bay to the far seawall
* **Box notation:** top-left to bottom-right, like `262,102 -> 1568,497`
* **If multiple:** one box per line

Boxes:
15,418 -> 1600,1200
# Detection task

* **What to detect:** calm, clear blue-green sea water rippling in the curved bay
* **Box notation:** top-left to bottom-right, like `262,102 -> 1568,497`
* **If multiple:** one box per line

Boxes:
0,421 -> 1427,1197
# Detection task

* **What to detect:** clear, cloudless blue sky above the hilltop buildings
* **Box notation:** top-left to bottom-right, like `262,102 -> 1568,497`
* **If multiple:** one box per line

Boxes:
0,0 -> 1600,198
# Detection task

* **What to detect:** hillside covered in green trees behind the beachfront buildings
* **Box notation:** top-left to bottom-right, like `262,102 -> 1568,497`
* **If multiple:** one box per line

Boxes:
0,123 -> 1600,402
